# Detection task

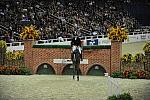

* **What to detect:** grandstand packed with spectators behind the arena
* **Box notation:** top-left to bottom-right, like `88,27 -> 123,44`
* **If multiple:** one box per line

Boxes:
0,0 -> 150,45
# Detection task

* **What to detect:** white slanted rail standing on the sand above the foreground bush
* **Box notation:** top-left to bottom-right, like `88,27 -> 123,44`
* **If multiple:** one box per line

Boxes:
108,76 -> 121,96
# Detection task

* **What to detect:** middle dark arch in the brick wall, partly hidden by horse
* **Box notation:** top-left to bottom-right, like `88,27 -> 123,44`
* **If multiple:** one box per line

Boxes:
62,64 -> 81,75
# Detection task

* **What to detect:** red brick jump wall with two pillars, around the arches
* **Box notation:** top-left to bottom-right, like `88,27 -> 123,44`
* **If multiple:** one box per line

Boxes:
24,41 -> 121,75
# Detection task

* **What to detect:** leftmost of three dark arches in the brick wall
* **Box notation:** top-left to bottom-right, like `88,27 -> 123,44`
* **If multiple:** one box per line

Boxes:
36,63 -> 55,74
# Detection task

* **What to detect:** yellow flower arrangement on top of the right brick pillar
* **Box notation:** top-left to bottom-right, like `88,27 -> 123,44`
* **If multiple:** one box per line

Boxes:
108,26 -> 128,42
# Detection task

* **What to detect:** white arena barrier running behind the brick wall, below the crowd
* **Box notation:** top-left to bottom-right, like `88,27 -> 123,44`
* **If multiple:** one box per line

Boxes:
7,31 -> 150,51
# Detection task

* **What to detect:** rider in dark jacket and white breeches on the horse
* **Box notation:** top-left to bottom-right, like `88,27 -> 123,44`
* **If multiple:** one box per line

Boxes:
71,35 -> 83,61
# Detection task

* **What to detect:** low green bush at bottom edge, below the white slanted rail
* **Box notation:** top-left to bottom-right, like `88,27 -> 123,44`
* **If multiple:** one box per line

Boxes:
107,93 -> 133,100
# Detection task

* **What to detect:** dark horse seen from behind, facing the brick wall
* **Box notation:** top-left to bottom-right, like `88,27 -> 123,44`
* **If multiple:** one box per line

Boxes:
71,48 -> 81,81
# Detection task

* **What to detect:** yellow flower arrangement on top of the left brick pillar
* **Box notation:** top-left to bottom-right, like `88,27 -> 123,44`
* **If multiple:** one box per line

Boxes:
20,25 -> 40,40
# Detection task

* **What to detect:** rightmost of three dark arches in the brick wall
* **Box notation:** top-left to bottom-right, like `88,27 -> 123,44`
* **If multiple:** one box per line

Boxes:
87,64 -> 106,76
